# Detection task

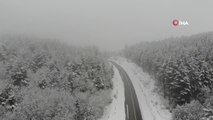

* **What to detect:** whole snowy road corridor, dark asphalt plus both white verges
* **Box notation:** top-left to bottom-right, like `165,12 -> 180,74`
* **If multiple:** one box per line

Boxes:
99,57 -> 172,120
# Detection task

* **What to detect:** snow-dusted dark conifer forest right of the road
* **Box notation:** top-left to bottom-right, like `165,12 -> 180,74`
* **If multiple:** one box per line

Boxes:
124,32 -> 213,120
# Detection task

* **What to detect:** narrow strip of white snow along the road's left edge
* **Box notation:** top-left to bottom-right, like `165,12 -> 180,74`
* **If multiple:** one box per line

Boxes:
99,67 -> 125,120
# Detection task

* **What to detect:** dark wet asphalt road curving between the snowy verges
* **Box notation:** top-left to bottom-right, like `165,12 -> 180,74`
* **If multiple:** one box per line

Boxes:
111,61 -> 143,120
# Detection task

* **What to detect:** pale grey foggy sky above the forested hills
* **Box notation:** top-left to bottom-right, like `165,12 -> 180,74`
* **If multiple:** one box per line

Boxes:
0,0 -> 213,50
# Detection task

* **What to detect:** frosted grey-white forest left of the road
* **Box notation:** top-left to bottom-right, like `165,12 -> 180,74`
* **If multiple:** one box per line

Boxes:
0,36 -> 113,120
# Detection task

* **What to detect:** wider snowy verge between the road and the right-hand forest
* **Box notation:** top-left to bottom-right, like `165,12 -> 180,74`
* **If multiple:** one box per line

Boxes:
115,58 -> 172,120
